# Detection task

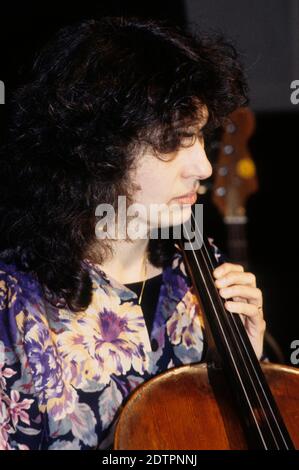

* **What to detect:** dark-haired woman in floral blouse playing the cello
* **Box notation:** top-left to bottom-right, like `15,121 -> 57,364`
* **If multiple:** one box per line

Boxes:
0,18 -> 265,449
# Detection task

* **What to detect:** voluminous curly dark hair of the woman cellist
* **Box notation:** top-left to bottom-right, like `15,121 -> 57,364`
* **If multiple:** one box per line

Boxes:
0,17 -> 248,312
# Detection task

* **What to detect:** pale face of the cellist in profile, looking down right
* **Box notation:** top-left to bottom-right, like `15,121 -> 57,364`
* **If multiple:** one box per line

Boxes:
133,107 -> 212,234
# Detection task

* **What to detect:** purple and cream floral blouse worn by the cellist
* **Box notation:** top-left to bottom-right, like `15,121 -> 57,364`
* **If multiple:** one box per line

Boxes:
0,240 -> 222,450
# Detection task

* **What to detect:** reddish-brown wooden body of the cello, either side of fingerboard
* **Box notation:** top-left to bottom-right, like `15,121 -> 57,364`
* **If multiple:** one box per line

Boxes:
114,363 -> 299,450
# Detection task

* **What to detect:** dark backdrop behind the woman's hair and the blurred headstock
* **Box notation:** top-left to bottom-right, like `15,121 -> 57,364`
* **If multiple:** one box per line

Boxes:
0,0 -> 299,363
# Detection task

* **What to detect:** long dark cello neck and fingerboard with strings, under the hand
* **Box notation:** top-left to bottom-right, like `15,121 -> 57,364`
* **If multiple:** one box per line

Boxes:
179,206 -> 294,450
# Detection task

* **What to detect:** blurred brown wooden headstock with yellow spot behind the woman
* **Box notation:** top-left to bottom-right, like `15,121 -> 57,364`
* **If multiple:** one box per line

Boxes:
212,107 -> 258,268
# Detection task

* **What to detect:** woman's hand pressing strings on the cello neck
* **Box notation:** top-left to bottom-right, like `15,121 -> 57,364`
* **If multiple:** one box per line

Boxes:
213,263 -> 266,359
